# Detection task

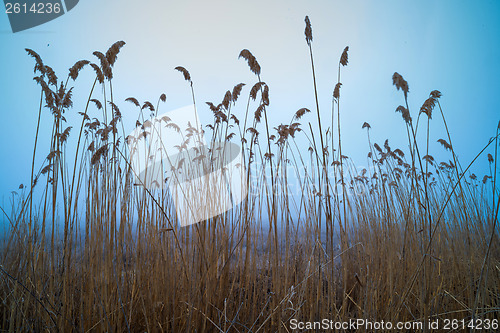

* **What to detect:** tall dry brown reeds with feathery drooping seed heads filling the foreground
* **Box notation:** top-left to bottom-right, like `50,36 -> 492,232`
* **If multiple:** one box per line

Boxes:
0,17 -> 500,332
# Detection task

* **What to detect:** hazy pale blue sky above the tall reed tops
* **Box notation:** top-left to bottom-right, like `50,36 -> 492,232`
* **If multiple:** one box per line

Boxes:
0,0 -> 500,205
